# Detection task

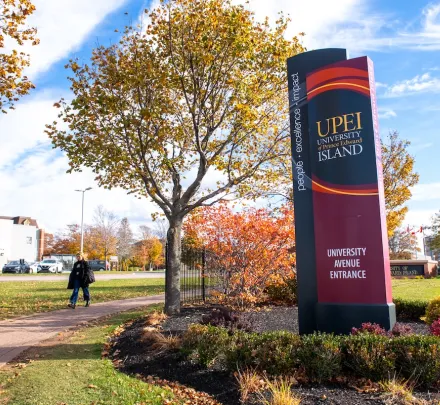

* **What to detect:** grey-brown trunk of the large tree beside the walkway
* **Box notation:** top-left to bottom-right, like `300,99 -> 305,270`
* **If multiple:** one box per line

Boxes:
165,219 -> 182,315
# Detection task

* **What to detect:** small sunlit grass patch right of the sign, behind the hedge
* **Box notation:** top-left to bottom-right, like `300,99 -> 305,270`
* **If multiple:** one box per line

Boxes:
393,278 -> 440,301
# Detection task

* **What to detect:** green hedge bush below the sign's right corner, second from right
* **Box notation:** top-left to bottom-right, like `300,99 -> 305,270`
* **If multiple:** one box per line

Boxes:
343,333 -> 395,381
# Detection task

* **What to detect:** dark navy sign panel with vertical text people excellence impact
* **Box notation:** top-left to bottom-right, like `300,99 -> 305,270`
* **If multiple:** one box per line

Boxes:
287,49 -> 347,334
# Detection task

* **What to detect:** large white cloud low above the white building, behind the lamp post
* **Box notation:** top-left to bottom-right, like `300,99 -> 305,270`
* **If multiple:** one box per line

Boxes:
0,149 -> 157,232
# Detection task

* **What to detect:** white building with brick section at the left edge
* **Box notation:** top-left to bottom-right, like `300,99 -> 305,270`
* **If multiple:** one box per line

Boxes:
0,216 -> 44,268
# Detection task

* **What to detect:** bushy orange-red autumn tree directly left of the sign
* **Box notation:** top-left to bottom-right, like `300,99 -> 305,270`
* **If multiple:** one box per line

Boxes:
184,205 -> 295,305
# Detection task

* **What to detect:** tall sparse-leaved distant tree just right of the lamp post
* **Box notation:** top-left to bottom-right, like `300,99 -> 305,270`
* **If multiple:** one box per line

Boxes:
93,205 -> 119,263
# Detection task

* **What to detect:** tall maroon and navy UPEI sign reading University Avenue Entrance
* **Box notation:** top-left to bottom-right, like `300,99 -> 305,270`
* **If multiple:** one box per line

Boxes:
287,49 -> 395,333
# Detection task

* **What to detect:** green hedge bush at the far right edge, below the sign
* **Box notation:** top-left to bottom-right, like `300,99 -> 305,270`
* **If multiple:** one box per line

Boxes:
391,335 -> 440,387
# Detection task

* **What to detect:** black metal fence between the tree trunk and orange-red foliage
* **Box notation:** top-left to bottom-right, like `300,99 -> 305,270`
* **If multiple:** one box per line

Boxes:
165,246 -> 223,304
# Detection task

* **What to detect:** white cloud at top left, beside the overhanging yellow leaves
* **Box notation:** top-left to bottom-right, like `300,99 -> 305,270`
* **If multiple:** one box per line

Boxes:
21,0 -> 127,77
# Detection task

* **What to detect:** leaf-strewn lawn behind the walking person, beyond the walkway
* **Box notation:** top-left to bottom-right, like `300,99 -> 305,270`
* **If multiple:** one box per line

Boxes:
0,278 -> 165,319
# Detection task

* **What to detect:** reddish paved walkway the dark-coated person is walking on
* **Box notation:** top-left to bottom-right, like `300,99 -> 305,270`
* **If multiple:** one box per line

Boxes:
0,295 -> 164,368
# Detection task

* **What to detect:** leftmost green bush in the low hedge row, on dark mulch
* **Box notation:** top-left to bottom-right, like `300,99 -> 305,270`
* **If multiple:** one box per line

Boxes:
182,324 -> 231,367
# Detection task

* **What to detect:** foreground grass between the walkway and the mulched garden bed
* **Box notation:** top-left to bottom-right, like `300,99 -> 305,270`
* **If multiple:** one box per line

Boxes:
0,306 -> 178,405
